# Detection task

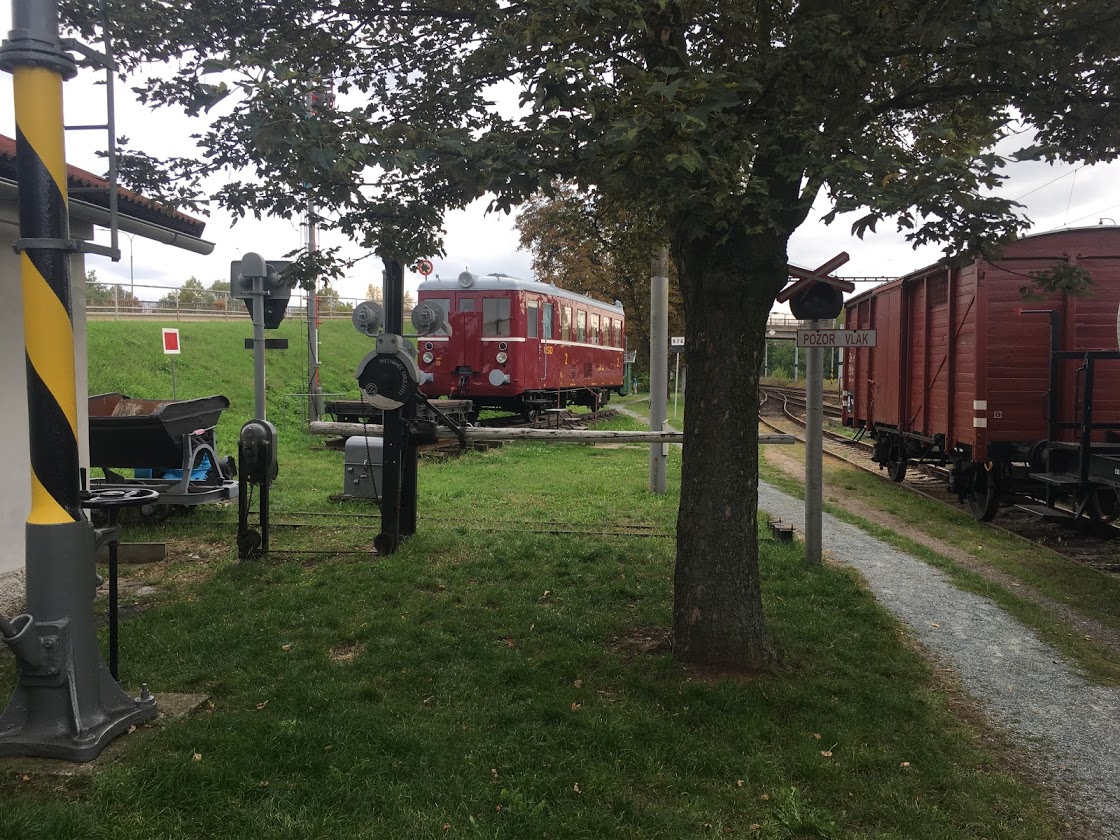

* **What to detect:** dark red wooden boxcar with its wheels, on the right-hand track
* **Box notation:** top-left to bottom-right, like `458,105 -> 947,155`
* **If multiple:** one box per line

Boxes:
841,226 -> 1120,520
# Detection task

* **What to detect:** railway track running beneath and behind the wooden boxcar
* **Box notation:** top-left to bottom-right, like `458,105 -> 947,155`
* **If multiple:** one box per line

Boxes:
758,386 -> 1120,573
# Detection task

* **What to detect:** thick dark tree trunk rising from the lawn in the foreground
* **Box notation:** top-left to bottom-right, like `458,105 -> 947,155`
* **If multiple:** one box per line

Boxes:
673,225 -> 788,669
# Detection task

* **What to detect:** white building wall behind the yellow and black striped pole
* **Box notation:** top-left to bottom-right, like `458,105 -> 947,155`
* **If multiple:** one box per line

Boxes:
0,203 -> 93,615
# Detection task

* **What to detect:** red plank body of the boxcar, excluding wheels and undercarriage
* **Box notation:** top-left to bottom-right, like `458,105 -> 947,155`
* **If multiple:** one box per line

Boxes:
842,227 -> 1120,460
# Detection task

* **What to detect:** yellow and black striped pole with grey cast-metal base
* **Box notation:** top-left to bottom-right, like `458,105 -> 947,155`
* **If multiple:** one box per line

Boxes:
0,0 -> 156,762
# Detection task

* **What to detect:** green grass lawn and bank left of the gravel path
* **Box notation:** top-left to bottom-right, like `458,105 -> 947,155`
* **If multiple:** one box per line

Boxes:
0,324 -> 1061,840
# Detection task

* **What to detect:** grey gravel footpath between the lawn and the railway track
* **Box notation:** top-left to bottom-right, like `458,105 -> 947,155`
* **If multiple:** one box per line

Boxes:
758,483 -> 1120,840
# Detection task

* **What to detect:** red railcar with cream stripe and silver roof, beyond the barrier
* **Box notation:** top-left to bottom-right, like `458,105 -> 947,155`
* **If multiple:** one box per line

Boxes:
418,272 -> 626,416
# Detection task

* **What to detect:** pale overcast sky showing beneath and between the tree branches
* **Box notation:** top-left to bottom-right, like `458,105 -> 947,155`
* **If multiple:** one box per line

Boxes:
0,20 -> 1120,313
